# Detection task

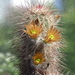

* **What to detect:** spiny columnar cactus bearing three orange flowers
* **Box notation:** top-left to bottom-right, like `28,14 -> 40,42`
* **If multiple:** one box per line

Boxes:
11,2 -> 68,75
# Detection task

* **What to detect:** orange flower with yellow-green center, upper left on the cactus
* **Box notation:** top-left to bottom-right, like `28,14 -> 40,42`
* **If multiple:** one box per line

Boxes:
23,21 -> 42,39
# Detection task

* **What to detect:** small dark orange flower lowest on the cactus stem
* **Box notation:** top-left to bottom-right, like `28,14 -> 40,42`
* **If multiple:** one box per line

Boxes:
32,52 -> 45,65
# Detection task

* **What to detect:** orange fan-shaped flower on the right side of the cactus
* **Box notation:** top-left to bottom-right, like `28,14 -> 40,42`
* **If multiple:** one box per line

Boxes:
44,26 -> 61,43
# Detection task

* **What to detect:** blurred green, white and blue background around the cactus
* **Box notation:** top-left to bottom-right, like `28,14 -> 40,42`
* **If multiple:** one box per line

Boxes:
0,0 -> 75,75
